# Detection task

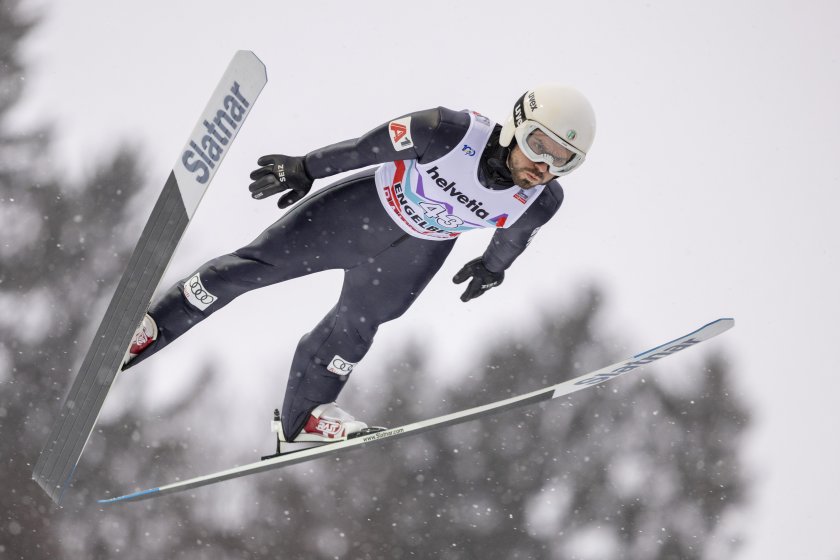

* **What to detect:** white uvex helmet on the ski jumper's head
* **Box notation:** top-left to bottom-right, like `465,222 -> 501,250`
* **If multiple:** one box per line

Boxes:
499,85 -> 595,176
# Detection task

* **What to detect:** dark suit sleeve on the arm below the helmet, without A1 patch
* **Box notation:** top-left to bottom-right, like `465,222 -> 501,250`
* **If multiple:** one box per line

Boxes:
483,181 -> 563,272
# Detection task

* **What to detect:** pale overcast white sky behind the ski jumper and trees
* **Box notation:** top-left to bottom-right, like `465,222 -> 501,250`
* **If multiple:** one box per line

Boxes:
11,0 -> 840,560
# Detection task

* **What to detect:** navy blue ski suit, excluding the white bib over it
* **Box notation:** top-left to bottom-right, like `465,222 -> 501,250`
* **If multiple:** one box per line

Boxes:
129,107 -> 563,441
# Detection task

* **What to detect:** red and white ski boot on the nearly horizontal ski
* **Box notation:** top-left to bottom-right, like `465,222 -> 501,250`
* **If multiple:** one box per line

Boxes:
263,403 -> 386,459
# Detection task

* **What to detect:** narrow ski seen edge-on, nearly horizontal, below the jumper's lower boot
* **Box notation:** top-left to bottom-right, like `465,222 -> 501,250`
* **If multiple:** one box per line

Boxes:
99,319 -> 735,504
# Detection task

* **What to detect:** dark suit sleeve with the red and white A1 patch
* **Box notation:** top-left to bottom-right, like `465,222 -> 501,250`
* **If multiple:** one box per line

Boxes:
304,107 -> 470,179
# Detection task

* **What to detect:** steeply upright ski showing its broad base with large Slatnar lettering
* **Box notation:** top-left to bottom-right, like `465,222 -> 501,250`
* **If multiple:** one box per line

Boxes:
32,51 -> 267,504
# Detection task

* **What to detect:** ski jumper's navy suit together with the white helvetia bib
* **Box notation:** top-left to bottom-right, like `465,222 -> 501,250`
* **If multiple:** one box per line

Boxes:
129,107 -> 563,441
